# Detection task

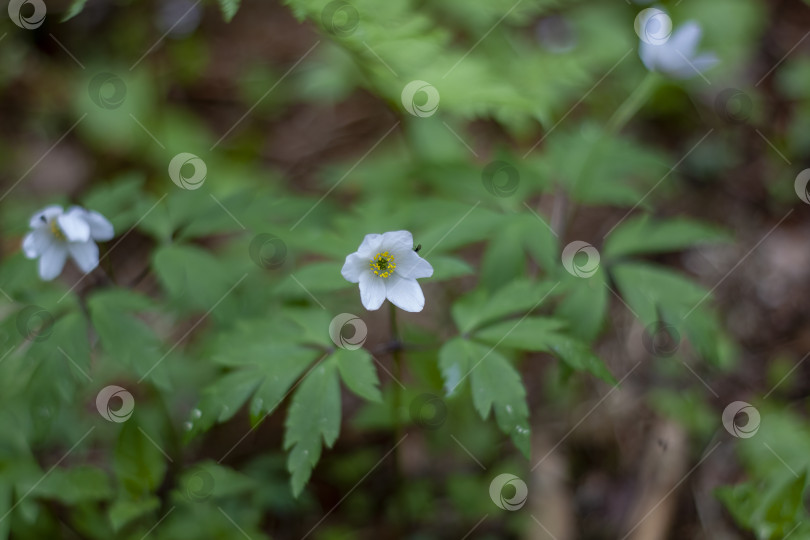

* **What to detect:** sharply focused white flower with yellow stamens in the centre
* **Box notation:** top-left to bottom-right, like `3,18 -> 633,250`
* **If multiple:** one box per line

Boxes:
340,231 -> 433,311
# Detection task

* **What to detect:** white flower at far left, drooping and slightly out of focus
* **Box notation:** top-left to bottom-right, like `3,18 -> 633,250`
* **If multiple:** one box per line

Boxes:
23,206 -> 115,281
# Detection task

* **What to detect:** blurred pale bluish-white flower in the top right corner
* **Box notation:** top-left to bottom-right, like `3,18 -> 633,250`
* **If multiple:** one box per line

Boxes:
638,21 -> 719,79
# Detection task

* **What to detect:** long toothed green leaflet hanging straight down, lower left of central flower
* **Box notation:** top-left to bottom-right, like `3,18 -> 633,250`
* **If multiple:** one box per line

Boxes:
284,358 -> 340,497
